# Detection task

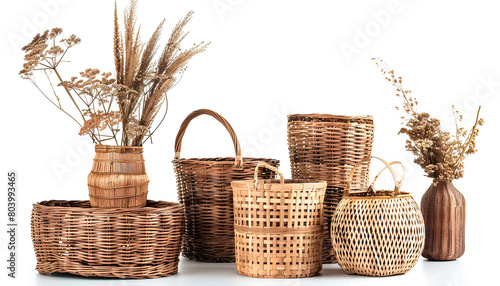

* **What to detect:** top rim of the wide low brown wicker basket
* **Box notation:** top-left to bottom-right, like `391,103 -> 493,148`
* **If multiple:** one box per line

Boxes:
33,200 -> 183,214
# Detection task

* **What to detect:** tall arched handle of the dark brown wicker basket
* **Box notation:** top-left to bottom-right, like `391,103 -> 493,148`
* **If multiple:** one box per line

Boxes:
174,109 -> 243,168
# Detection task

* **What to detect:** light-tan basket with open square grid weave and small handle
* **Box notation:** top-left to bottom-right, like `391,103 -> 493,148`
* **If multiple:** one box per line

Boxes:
232,163 -> 326,278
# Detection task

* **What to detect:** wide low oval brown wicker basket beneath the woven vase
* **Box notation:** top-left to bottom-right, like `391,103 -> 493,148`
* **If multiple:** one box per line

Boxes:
31,201 -> 184,278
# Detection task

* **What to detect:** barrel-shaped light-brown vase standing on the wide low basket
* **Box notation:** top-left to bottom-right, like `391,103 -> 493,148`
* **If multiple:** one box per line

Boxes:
88,145 -> 149,208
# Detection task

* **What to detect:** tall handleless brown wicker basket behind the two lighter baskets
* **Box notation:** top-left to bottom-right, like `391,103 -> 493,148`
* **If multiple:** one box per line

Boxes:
288,114 -> 374,263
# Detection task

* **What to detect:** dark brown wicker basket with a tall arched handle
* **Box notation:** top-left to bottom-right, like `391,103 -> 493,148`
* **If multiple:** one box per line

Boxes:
173,109 -> 279,262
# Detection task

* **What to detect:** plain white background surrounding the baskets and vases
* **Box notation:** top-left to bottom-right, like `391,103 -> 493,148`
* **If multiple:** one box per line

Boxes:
0,0 -> 500,285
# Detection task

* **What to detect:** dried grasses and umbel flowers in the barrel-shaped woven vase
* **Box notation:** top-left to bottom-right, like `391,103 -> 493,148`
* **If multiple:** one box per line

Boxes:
19,0 -> 210,146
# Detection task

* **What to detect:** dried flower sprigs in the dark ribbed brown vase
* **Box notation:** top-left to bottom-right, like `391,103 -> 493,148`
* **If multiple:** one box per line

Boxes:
373,58 -> 484,184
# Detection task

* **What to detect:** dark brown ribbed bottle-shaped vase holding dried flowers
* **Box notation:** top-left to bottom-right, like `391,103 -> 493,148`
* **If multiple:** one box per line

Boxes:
420,181 -> 465,260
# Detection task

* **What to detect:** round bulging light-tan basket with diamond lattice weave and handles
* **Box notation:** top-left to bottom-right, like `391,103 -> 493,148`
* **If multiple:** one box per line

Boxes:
332,157 -> 425,276
